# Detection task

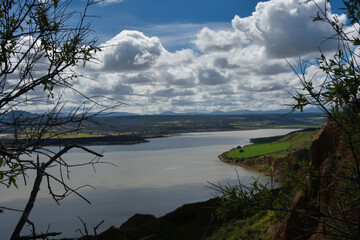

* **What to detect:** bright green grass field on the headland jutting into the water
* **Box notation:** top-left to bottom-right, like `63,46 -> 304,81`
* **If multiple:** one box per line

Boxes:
227,142 -> 291,159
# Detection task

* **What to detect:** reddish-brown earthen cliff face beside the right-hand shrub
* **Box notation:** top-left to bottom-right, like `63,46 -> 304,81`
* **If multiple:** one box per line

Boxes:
271,123 -> 359,240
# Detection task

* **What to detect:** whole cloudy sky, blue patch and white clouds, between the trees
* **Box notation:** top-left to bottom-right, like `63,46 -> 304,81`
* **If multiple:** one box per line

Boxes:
62,0 -> 344,114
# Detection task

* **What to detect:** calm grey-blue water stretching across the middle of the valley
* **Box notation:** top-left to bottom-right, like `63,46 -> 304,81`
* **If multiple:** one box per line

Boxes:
0,129 -> 296,239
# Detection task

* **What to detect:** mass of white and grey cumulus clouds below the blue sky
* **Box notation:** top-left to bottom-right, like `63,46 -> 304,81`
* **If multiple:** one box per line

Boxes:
67,0 -> 346,113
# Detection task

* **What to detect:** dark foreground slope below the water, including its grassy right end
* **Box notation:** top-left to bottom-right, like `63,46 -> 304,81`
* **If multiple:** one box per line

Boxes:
63,190 -> 279,240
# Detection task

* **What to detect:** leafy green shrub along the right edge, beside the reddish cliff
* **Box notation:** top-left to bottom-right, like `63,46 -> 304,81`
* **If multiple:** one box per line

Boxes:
293,0 -> 360,238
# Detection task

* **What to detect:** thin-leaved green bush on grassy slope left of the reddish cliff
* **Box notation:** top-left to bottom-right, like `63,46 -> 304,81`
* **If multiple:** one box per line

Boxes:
209,170 -> 306,240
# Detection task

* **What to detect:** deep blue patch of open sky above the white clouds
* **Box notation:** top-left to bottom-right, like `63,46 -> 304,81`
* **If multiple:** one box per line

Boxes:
81,0 -> 259,51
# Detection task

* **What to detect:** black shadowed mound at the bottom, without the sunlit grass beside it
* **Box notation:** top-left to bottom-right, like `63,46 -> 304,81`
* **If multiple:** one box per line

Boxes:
67,198 -> 223,240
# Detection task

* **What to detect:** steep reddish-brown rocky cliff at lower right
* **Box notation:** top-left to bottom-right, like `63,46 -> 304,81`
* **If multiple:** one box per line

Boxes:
270,123 -> 359,240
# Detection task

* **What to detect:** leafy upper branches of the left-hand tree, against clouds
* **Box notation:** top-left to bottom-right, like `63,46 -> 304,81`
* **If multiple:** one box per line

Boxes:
0,0 -> 97,186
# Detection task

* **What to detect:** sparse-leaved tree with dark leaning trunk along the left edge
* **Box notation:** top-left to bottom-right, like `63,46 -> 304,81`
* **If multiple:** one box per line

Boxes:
0,0 -> 116,240
